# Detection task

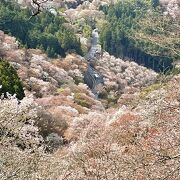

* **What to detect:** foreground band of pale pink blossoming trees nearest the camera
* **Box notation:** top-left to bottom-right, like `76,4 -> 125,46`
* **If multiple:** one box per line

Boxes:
0,76 -> 180,180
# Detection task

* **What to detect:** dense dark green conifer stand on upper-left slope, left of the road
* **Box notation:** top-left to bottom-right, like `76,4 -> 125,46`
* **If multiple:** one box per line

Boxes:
0,0 -> 82,57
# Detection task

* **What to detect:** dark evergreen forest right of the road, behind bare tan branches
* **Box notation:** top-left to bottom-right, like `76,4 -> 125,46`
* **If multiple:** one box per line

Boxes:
100,0 -> 180,72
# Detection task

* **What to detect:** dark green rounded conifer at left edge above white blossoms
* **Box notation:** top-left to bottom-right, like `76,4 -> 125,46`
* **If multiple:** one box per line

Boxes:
0,59 -> 25,99
